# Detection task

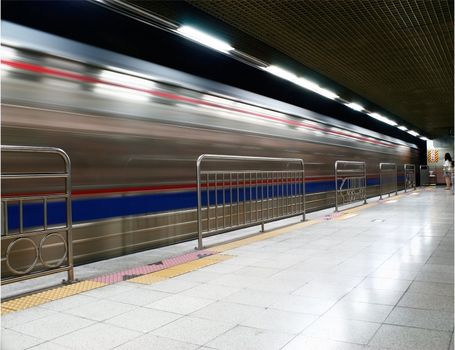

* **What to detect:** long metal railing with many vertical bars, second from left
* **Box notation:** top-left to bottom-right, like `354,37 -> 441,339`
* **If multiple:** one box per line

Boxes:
196,154 -> 305,249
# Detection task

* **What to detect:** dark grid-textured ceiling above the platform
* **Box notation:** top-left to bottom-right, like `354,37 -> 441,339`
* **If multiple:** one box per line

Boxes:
128,0 -> 454,137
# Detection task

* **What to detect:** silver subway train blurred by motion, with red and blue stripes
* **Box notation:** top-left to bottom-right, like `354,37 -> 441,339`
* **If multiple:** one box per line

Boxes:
1,22 -> 419,275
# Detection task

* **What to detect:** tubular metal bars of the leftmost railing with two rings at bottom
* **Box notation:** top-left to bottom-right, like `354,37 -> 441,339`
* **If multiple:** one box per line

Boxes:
0,145 -> 74,284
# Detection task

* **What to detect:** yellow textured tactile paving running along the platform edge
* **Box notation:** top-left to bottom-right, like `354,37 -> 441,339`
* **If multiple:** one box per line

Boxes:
0,191 -> 418,315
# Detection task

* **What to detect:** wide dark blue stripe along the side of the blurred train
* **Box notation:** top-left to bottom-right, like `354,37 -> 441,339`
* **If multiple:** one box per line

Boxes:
8,177 -> 402,231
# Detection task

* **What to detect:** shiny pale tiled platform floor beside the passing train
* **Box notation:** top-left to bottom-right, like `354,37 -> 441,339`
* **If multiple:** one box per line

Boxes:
1,187 -> 454,350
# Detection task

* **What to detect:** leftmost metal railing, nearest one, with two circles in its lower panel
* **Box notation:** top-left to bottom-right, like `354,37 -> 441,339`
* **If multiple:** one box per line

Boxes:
1,146 -> 74,284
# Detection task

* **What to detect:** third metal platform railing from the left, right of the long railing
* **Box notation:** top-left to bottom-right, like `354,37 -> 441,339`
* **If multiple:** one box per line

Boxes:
335,160 -> 367,211
